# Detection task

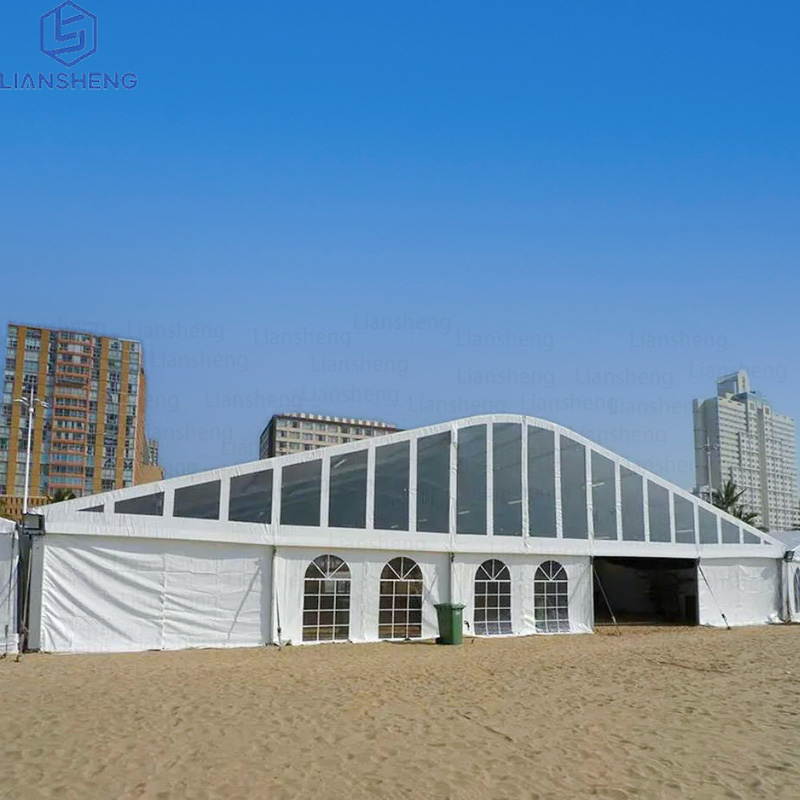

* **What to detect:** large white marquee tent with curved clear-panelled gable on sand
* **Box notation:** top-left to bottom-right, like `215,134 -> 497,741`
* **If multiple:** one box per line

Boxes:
21,414 -> 800,652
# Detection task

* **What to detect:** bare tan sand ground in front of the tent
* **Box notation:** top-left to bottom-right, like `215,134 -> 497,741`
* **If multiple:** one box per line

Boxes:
0,626 -> 800,798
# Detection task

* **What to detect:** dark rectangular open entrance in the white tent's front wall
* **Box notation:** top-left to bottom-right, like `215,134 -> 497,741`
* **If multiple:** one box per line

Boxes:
594,557 -> 697,625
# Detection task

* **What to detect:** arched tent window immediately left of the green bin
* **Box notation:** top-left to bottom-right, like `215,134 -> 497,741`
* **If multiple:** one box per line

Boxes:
378,556 -> 422,639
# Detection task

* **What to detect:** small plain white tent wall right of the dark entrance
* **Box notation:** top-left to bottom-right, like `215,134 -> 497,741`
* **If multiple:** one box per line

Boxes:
697,558 -> 782,627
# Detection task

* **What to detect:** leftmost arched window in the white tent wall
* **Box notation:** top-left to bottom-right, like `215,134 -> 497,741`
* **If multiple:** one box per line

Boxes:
303,556 -> 350,642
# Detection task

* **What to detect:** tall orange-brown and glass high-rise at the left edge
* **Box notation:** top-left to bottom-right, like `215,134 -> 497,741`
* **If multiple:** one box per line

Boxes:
0,324 -> 158,515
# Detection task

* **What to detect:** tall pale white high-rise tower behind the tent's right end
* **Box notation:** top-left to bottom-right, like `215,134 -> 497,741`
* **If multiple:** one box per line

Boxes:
694,370 -> 798,530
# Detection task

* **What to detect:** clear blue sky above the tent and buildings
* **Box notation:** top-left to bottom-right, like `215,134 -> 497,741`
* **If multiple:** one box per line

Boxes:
0,0 -> 800,487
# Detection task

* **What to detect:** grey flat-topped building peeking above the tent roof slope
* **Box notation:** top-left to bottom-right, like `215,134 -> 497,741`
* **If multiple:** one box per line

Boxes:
258,414 -> 400,458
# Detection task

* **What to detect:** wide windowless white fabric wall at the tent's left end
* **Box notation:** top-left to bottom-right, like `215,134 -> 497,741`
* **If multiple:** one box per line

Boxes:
35,535 -> 270,653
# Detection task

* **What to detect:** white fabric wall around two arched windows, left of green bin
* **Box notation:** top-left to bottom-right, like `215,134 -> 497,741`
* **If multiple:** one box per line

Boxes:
275,547 -> 450,644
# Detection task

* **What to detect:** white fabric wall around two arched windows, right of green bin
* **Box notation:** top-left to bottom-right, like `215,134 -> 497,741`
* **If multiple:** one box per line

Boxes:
453,553 -> 593,636
